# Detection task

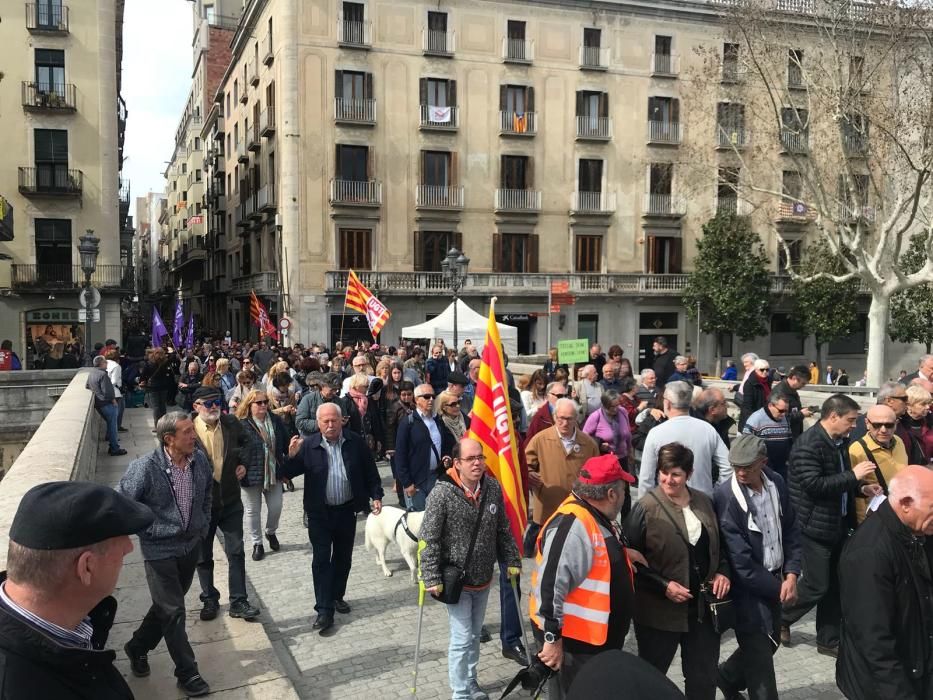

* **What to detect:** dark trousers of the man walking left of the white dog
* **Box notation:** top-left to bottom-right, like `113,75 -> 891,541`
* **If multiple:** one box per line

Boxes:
308,502 -> 356,617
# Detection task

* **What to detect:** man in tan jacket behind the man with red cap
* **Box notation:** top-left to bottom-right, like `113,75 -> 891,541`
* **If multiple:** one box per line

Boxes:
525,398 -> 599,525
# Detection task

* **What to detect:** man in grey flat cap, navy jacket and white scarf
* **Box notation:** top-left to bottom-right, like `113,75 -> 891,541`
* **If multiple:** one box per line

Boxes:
714,434 -> 801,700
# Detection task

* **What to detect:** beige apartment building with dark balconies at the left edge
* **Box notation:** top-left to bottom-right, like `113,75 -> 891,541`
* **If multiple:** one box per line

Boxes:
0,0 -> 133,366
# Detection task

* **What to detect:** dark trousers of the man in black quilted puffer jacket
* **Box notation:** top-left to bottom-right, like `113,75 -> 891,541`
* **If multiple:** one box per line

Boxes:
784,532 -> 845,647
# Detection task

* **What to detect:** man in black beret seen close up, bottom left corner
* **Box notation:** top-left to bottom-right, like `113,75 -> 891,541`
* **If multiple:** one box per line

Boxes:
0,481 -> 153,700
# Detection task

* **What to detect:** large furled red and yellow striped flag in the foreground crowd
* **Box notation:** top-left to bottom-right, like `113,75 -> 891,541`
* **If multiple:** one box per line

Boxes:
469,297 -> 528,551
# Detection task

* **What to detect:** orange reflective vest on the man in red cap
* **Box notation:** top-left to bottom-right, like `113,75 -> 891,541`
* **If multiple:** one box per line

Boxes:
528,494 -> 628,646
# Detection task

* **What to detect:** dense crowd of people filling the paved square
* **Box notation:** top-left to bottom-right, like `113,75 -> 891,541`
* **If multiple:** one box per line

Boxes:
0,336 -> 933,700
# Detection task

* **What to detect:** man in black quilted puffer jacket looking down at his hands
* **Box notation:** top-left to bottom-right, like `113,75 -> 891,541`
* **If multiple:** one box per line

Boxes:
781,394 -> 875,656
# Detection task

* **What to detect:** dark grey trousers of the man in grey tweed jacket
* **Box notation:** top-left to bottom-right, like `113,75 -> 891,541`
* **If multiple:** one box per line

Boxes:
129,547 -> 199,680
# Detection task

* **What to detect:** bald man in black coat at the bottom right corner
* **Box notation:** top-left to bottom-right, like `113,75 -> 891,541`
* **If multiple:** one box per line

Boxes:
836,466 -> 933,700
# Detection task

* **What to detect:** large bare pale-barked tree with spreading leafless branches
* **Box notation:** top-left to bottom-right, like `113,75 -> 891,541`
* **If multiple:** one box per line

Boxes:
695,0 -> 933,386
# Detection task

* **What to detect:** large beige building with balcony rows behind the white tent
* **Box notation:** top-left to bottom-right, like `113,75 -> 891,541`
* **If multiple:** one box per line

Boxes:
200,0 -> 912,372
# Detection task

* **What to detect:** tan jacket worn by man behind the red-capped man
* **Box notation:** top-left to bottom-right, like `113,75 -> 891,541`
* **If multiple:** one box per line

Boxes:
525,426 -> 599,525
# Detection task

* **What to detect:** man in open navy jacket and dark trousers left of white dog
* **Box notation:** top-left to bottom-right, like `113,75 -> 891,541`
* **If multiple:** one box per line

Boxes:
285,403 -> 383,636
